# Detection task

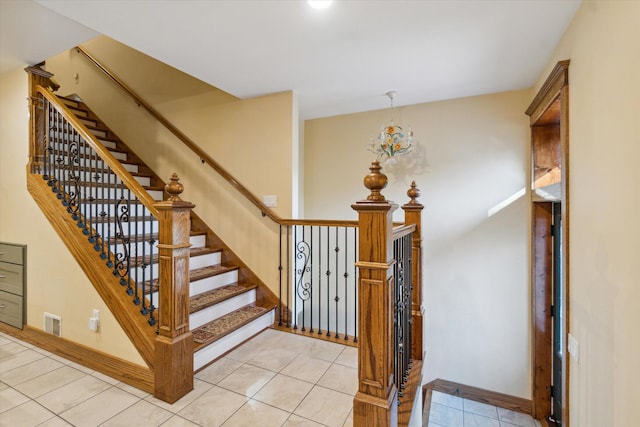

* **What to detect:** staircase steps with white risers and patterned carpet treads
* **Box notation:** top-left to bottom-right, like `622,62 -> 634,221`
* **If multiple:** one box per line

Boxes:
55,96 -> 275,371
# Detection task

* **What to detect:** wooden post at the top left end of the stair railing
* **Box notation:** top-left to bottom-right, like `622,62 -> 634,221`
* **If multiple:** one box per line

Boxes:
24,66 -> 60,173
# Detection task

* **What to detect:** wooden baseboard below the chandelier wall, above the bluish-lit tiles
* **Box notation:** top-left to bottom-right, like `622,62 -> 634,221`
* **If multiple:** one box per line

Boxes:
422,379 -> 532,415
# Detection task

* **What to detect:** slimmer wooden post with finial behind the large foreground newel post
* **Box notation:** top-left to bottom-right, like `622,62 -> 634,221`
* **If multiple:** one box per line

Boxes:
402,181 -> 424,360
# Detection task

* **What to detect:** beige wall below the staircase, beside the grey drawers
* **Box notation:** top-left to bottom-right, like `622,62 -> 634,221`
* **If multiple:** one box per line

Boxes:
0,65 -> 144,365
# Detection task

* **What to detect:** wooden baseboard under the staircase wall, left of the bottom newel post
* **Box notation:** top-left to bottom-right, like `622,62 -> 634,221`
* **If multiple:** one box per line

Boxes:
0,322 -> 154,393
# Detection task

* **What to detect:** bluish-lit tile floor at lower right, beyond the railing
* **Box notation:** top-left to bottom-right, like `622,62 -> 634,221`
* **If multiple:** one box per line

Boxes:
428,391 -> 540,427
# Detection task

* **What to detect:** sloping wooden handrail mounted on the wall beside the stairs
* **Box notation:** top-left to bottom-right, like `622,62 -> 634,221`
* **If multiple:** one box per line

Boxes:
75,46 -> 284,225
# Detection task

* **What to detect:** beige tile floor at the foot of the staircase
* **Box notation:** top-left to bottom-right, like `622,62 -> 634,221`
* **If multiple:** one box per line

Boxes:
0,329 -> 358,427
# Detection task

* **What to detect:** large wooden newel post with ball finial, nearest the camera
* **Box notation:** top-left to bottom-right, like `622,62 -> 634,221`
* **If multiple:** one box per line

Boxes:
351,161 -> 398,427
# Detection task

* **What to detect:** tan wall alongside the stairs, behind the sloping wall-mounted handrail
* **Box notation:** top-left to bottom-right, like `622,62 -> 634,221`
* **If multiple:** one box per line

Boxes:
47,37 -> 298,290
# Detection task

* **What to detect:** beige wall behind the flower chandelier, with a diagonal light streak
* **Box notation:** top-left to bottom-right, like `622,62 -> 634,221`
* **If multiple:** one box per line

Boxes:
304,90 -> 532,398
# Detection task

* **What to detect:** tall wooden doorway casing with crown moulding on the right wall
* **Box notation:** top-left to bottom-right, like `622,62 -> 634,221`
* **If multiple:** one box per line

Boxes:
526,60 -> 571,426
